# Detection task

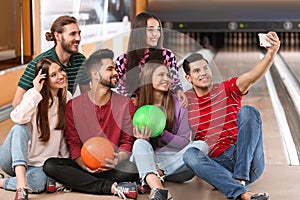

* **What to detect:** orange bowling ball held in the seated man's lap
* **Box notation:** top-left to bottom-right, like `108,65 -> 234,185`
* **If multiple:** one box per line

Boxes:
81,137 -> 114,170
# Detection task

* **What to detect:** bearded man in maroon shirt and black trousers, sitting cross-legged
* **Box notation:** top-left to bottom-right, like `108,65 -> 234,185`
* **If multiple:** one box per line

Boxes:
44,49 -> 139,198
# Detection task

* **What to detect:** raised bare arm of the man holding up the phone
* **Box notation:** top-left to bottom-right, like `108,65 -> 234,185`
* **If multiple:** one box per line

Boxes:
236,32 -> 280,94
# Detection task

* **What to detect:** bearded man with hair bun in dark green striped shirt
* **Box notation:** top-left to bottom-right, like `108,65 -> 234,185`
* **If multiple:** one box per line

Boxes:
12,16 -> 89,107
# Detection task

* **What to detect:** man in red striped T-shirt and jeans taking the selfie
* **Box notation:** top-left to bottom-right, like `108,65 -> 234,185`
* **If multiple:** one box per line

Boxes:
183,32 -> 280,200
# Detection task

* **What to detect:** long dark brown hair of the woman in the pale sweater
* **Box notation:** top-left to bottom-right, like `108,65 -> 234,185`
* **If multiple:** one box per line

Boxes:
34,57 -> 67,142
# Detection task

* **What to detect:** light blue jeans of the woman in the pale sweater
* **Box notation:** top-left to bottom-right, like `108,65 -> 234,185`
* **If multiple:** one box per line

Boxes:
0,124 -> 47,192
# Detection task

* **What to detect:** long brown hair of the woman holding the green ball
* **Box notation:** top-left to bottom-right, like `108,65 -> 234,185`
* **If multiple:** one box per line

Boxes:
139,60 -> 175,132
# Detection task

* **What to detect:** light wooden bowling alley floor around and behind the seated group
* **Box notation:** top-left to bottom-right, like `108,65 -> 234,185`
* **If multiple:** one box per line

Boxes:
0,52 -> 300,200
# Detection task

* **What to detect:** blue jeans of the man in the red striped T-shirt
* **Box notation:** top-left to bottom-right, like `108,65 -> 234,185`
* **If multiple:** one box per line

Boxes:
183,106 -> 265,199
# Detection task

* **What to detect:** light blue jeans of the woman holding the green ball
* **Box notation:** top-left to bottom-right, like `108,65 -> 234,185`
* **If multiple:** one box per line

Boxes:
131,139 -> 208,184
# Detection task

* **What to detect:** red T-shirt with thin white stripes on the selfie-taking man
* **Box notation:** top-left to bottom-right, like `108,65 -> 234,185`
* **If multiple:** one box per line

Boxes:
186,77 -> 243,158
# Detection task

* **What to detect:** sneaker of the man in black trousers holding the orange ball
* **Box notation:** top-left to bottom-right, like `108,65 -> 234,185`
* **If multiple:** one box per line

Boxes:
114,182 -> 137,199
